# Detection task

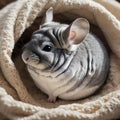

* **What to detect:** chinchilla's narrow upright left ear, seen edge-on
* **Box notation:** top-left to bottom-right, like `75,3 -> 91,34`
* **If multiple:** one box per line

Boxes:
41,7 -> 53,25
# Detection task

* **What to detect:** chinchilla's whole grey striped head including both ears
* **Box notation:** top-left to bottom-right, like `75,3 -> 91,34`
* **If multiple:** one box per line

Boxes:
22,8 -> 89,70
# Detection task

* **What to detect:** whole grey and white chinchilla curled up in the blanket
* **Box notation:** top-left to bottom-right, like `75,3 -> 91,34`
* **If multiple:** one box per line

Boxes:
22,9 -> 109,102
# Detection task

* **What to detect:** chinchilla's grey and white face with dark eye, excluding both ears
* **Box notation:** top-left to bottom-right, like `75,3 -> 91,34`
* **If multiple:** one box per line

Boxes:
22,26 -> 70,69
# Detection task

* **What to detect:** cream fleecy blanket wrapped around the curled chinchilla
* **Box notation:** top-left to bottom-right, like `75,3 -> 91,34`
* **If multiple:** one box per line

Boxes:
0,0 -> 120,120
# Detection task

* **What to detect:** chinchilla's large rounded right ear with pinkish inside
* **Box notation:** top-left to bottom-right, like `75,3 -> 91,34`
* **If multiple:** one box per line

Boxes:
63,18 -> 90,47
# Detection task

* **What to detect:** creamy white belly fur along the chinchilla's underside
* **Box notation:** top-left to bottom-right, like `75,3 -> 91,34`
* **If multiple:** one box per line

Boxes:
28,61 -> 99,100
